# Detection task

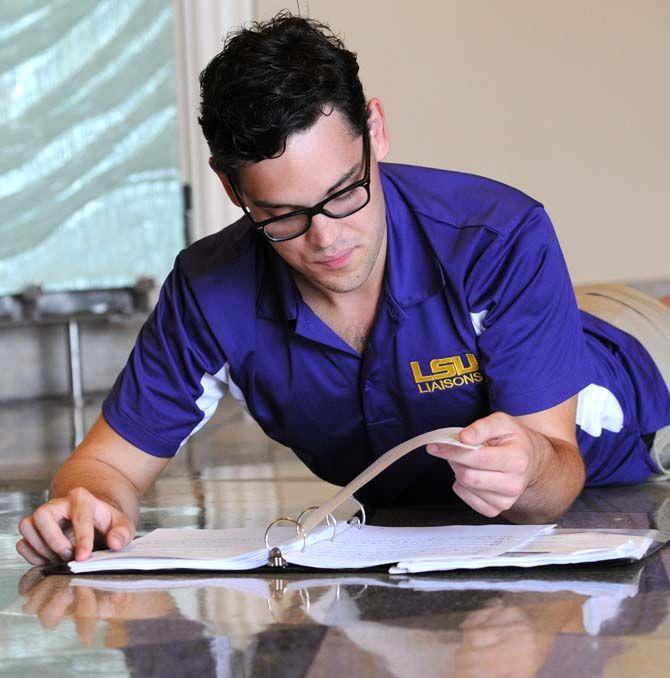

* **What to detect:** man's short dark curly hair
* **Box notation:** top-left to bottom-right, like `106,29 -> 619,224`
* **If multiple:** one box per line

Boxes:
198,11 -> 367,175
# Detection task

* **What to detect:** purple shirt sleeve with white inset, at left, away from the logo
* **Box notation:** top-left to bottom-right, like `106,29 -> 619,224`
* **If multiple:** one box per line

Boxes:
102,259 -> 228,457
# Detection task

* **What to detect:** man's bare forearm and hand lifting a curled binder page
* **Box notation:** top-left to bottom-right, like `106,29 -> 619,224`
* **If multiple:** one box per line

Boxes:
428,395 -> 585,523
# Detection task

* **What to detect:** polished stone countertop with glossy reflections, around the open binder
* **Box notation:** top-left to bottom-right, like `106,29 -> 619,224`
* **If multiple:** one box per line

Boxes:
0,403 -> 670,678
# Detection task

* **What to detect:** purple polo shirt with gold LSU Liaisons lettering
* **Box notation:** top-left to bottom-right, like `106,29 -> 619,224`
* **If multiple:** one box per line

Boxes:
103,163 -> 670,504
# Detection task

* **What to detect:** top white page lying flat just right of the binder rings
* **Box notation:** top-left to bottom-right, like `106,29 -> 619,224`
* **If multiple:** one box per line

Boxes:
284,525 -> 553,569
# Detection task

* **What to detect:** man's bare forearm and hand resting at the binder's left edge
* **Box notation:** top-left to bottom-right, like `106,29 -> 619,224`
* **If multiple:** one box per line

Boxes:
16,416 -> 169,565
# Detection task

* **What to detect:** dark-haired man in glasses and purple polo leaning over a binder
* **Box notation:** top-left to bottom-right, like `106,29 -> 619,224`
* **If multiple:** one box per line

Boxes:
17,14 -> 670,564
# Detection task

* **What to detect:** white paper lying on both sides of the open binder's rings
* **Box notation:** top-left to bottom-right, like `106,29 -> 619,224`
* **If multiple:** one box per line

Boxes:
69,524 -> 660,573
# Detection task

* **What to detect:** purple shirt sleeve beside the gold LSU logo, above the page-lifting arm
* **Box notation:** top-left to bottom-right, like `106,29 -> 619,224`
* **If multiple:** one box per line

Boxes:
466,205 -> 595,416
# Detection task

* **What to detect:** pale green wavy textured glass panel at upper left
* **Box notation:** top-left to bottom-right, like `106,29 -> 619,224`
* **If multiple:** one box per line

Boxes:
0,0 -> 184,294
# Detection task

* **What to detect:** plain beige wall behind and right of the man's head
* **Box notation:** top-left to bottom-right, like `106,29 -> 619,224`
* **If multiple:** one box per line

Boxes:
256,0 -> 670,282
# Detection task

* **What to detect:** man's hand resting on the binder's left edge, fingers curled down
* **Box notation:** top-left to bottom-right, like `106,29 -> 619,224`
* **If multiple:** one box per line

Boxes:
16,487 -> 135,565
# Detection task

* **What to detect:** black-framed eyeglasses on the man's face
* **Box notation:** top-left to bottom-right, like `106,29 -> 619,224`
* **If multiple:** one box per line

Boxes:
228,131 -> 370,242
